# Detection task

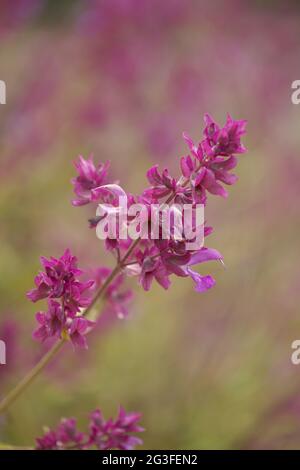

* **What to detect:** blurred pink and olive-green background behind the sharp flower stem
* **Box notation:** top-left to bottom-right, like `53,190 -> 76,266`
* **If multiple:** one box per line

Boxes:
0,0 -> 300,449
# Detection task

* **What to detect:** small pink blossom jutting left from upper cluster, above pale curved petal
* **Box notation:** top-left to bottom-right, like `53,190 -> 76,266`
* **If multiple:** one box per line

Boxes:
72,155 -> 109,206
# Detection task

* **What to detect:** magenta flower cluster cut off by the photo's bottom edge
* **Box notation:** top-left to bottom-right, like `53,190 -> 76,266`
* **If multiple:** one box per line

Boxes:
36,407 -> 144,450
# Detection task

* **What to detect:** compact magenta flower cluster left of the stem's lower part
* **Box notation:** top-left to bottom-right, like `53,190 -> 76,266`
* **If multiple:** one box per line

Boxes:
27,249 -> 94,348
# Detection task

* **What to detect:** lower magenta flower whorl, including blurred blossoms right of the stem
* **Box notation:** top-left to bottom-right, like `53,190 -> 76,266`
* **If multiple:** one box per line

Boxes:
27,250 -> 133,348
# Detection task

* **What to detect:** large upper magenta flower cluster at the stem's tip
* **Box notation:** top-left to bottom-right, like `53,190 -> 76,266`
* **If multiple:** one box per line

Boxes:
72,114 -> 246,292
